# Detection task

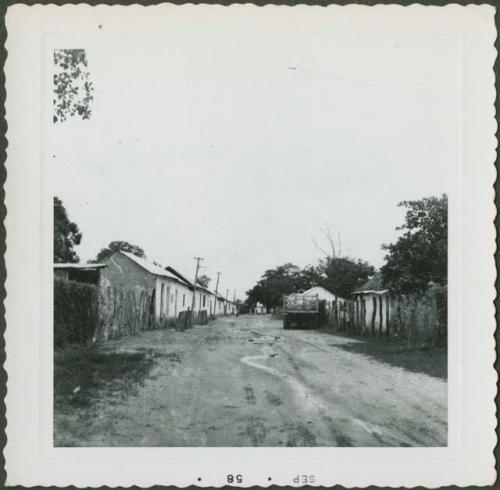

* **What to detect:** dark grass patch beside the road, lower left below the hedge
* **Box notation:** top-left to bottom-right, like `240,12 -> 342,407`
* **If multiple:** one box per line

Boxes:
54,348 -> 154,411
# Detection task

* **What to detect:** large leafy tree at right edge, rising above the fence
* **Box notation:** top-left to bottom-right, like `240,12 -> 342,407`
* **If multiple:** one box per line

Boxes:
381,194 -> 448,294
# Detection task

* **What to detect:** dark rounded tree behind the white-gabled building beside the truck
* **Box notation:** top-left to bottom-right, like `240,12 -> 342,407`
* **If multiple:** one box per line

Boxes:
316,257 -> 375,298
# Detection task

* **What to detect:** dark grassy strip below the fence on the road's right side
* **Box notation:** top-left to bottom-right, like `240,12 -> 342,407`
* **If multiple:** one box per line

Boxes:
326,337 -> 448,379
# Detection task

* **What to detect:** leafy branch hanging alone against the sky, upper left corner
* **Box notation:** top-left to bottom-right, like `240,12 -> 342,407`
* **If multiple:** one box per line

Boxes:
53,49 -> 94,123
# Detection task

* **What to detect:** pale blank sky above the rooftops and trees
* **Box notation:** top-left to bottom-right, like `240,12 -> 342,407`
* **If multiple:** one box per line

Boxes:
46,28 -> 459,299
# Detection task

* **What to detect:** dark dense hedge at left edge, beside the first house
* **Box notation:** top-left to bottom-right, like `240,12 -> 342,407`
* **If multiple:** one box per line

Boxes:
54,279 -> 99,347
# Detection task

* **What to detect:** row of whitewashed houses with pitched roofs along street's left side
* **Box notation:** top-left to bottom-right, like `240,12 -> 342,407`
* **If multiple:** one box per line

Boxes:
54,251 -> 236,339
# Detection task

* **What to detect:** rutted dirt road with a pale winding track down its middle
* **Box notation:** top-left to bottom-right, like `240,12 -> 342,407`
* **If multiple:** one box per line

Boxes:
54,315 -> 447,446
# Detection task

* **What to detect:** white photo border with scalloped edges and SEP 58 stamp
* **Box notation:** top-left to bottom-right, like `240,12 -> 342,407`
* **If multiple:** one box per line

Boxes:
4,4 -> 497,487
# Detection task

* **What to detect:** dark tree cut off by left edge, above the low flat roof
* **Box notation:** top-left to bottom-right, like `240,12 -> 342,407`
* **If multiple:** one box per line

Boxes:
54,197 -> 82,263
